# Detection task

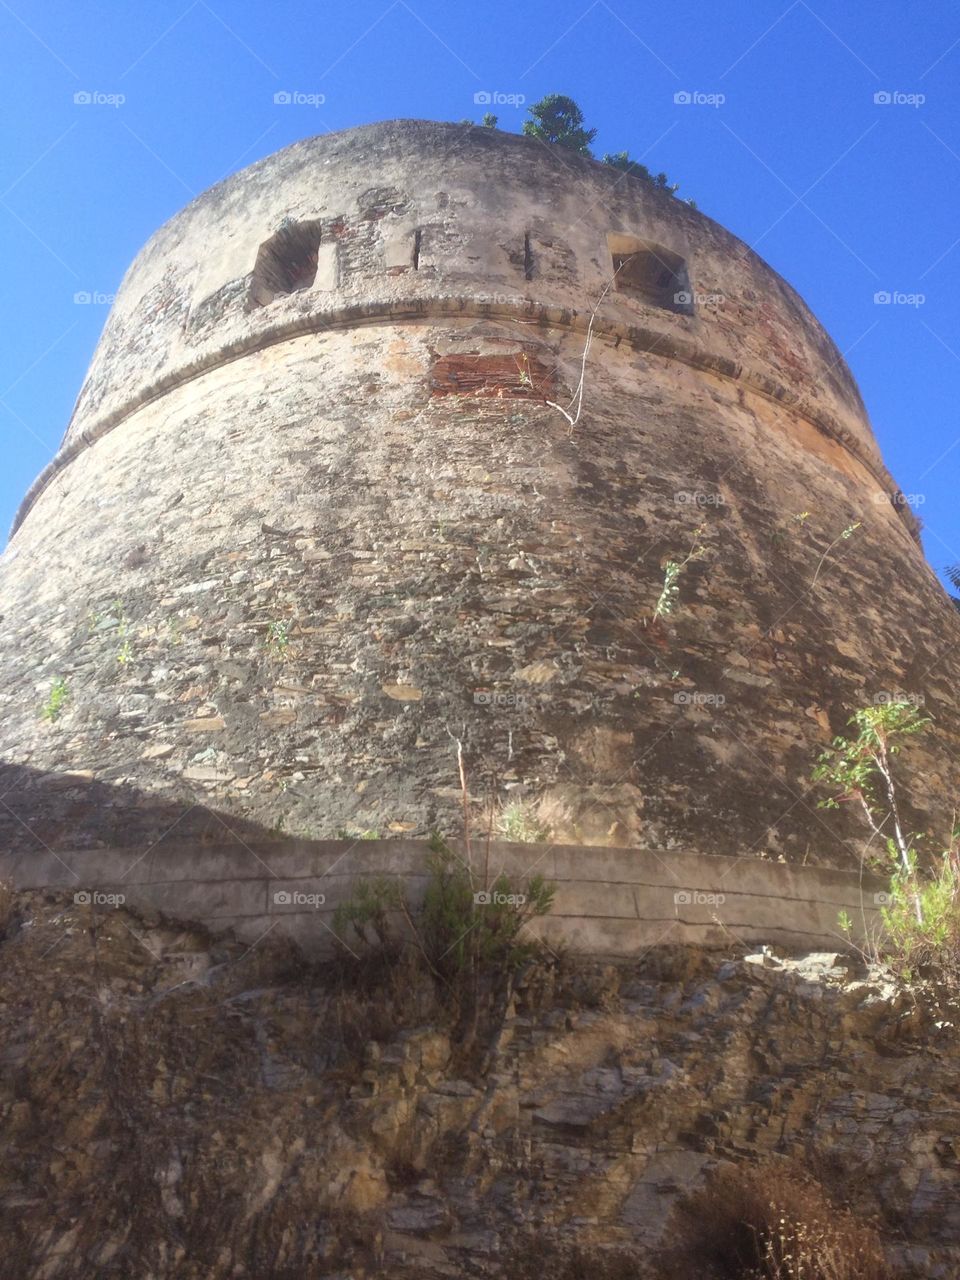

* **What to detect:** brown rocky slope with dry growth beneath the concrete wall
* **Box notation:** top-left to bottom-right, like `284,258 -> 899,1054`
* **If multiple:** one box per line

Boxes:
0,893 -> 960,1280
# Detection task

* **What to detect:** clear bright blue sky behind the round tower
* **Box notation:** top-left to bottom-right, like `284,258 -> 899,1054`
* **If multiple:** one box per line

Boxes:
0,0 -> 960,586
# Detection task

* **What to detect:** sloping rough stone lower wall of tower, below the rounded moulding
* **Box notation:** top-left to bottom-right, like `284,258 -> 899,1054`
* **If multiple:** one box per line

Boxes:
0,321 -> 960,865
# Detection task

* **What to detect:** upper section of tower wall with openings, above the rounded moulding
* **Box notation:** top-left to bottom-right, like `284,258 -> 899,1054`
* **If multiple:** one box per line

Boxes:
22,120 -> 910,520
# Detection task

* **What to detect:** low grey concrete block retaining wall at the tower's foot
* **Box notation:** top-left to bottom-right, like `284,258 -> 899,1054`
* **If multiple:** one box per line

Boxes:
0,840 -> 883,957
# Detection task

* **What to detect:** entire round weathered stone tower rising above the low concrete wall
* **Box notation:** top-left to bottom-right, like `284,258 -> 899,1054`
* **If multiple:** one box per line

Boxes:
0,120 -> 960,865
